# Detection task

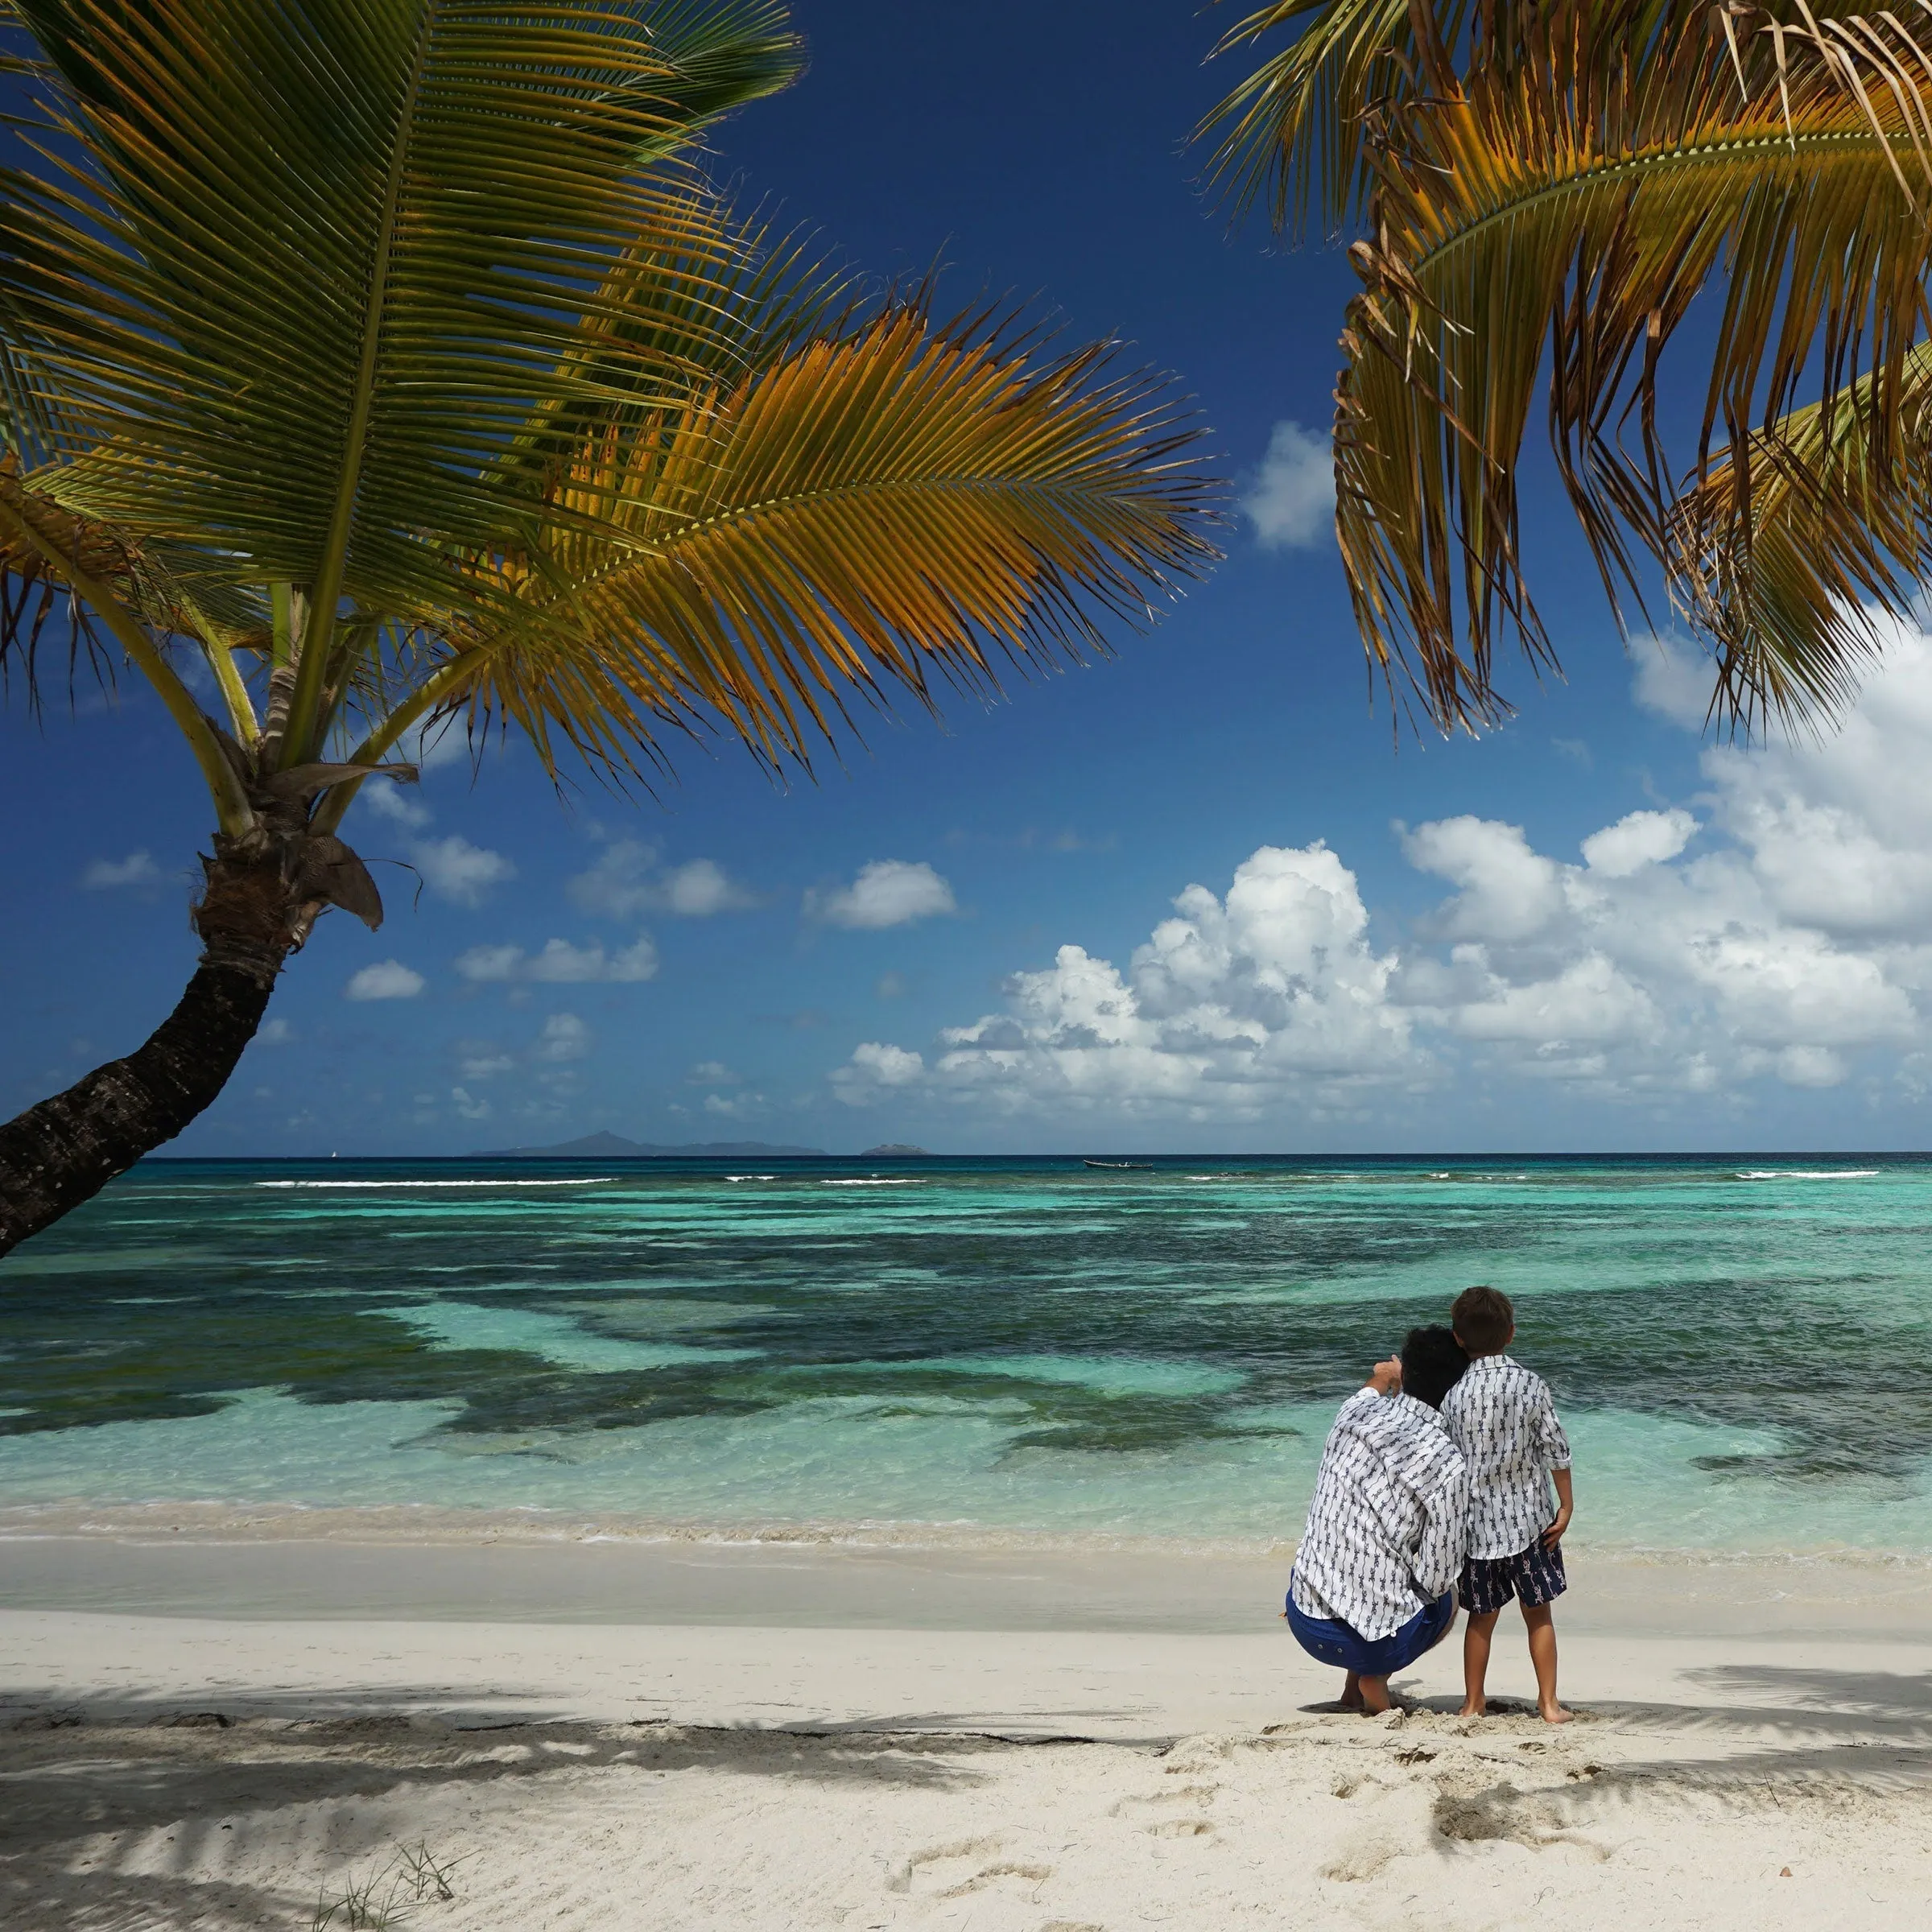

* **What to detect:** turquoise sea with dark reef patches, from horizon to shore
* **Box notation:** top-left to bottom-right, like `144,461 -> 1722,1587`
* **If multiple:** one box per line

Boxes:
0,1155 -> 1932,1557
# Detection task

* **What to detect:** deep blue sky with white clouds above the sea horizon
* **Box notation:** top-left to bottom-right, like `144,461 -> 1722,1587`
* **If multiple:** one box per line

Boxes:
0,0 -> 1932,1154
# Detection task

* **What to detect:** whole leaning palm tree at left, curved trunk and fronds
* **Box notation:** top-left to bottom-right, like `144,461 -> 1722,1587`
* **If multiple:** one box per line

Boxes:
0,0 -> 1213,1252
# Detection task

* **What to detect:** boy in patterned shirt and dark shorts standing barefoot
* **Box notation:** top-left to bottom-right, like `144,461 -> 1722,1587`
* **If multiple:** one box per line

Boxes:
1441,1289 -> 1575,1724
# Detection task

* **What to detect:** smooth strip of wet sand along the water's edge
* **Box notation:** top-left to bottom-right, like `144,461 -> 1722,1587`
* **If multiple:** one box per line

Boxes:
0,1518 -> 1932,1642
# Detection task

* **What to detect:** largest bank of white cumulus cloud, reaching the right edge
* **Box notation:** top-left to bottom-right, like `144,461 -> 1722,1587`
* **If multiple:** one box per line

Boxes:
831,630 -> 1932,1125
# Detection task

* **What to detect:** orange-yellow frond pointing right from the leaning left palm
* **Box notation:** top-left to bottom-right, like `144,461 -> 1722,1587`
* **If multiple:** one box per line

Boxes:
421,291 -> 1216,773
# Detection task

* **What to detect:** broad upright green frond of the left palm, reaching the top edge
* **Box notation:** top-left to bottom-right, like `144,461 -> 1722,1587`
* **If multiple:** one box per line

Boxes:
0,0 -> 792,762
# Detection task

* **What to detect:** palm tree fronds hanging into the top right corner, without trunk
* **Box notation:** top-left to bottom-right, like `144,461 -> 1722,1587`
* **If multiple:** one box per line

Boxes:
1203,0 -> 1932,730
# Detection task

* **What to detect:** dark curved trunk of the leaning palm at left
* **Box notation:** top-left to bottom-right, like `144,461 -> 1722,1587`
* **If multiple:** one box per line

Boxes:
0,840 -> 303,1254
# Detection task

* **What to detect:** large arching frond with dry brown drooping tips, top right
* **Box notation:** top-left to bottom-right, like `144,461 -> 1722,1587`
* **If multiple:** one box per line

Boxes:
1337,6 -> 1932,729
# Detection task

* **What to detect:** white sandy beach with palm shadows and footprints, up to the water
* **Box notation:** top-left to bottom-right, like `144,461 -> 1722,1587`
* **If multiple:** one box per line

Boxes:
0,1538 -> 1932,1932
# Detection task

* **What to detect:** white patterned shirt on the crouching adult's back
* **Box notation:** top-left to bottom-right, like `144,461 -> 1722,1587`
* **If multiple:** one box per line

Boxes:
1290,1389 -> 1468,1642
